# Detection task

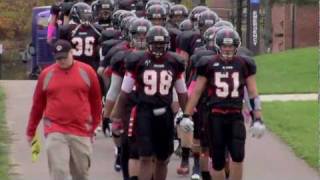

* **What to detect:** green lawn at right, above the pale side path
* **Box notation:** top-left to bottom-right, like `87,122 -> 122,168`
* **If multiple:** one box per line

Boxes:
255,48 -> 318,94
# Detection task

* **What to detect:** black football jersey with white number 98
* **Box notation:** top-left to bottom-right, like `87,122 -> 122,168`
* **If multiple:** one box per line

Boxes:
125,51 -> 184,108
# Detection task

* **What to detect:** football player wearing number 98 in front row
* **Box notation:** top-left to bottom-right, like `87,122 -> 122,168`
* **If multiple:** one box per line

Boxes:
112,26 -> 187,180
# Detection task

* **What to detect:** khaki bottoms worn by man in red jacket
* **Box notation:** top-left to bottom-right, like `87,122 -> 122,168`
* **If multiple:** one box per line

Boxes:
46,133 -> 92,180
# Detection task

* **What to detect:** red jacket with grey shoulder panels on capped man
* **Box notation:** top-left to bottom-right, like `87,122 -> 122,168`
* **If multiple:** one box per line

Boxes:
27,61 -> 102,137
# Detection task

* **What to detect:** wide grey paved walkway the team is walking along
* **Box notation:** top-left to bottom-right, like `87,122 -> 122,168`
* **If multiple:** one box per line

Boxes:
0,81 -> 320,180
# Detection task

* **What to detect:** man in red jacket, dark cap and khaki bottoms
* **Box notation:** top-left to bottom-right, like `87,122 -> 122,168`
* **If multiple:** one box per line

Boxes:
26,40 -> 102,180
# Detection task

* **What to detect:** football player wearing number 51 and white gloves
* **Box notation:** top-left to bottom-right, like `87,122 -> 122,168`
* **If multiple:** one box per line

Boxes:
180,28 -> 265,180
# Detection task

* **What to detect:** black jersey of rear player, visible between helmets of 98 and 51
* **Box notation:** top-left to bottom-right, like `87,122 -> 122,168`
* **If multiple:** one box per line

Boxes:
176,30 -> 204,56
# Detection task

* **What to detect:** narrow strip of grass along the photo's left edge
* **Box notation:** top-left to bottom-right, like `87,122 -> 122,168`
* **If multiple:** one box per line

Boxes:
0,88 -> 9,180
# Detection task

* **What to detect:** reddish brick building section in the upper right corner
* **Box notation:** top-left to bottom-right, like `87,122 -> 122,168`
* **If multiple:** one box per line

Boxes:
272,4 -> 319,52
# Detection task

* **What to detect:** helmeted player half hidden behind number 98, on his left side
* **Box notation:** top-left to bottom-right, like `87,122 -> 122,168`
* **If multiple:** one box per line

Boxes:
106,18 -> 151,179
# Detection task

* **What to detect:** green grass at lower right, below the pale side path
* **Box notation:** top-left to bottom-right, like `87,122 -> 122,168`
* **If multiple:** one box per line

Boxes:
263,101 -> 319,168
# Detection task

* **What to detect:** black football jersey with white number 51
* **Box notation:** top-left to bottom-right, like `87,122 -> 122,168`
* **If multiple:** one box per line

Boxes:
197,55 -> 256,109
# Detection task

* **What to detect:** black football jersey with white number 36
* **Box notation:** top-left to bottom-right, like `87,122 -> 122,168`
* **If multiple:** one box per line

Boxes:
59,24 -> 101,69
